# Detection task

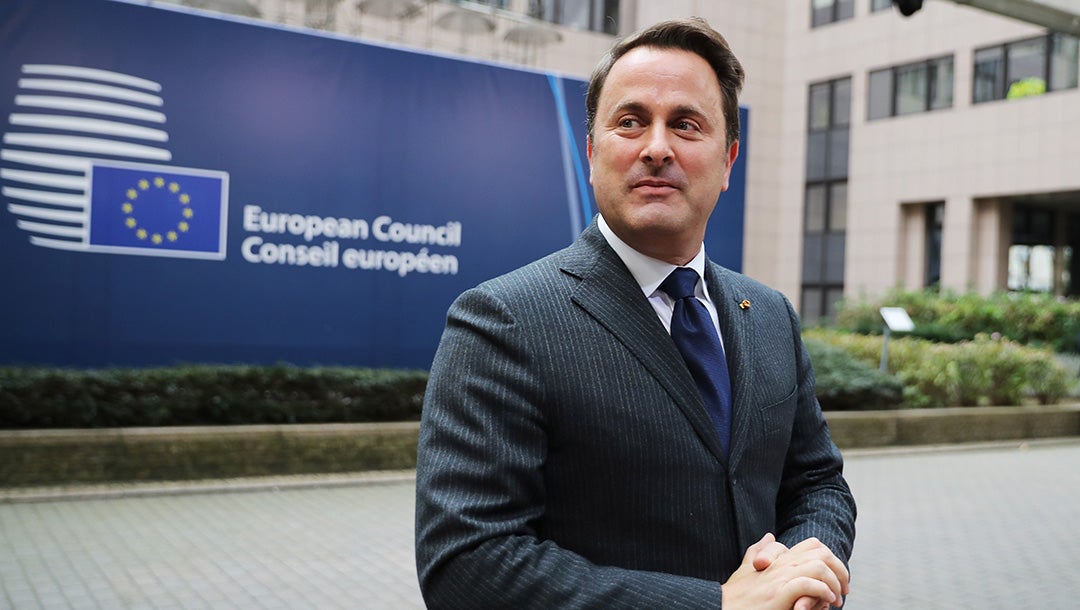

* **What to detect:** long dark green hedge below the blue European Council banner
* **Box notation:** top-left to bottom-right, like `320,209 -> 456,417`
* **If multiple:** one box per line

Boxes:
0,365 -> 428,429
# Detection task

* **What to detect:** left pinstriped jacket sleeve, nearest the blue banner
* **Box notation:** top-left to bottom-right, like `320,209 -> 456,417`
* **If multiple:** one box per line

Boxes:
416,286 -> 720,609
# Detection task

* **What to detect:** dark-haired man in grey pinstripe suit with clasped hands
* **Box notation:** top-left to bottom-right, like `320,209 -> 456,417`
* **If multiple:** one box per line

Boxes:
416,19 -> 855,610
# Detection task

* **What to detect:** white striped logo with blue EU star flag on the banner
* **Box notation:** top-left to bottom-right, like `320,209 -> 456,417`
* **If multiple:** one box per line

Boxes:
0,64 -> 229,260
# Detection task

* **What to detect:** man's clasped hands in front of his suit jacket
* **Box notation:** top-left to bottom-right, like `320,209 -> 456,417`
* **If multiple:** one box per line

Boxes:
721,533 -> 849,610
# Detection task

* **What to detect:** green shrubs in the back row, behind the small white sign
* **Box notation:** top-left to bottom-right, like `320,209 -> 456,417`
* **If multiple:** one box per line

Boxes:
834,289 -> 1080,352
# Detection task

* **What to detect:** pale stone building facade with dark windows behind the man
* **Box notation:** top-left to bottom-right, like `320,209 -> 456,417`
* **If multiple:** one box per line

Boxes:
170,0 -> 1080,323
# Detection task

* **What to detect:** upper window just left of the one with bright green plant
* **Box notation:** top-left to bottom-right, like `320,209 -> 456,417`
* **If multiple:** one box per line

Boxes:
866,56 -> 953,120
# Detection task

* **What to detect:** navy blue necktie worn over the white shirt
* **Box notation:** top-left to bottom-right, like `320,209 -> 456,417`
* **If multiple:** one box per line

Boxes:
660,267 -> 731,455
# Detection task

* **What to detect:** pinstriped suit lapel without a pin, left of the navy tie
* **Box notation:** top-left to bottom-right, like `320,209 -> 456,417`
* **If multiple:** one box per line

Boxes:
562,222 -> 726,462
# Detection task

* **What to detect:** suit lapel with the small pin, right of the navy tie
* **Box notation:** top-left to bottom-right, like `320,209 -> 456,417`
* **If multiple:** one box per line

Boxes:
705,261 -> 755,464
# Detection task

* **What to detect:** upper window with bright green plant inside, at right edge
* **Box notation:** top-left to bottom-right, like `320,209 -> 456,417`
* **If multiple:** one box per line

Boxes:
972,32 -> 1080,104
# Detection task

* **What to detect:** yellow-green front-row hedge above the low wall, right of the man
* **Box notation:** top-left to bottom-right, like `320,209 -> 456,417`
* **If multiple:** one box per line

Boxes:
806,329 -> 1074,407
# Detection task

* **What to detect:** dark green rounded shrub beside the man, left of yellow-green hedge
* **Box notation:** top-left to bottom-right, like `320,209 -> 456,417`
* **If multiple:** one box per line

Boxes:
806,338 -> 904,411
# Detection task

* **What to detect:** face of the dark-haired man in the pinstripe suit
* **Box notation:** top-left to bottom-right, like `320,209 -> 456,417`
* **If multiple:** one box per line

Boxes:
588,46 -> 739,265
